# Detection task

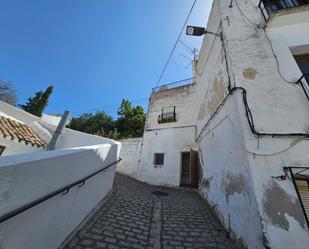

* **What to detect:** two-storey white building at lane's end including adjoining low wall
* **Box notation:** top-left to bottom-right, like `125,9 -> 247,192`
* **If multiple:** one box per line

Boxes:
117,81 -> 198,187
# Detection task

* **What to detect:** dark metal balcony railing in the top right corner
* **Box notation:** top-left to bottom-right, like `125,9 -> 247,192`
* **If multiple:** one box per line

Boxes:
259,0 -> 309,21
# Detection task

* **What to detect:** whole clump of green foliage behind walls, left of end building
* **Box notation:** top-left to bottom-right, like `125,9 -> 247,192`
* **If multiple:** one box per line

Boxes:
68,99 -> 146,140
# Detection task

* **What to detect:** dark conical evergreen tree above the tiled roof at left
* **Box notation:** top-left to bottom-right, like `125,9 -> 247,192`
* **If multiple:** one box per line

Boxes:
19,86 -> 53,117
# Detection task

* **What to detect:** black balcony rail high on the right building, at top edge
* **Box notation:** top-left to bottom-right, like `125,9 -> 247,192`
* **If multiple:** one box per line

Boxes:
258,0 -> 309,21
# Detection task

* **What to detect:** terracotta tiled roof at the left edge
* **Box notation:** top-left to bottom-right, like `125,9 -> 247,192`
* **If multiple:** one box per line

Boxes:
0,116 -> 46,147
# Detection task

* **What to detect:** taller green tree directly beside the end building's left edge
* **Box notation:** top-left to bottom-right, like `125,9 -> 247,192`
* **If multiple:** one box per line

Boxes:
116,99 -> 146,138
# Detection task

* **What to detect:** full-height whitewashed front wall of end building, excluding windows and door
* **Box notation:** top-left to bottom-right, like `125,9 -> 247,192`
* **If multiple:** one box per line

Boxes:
137,84 -> 196,186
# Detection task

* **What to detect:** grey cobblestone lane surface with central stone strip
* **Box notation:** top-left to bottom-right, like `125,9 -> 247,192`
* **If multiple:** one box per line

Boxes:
62,175 -> 236,249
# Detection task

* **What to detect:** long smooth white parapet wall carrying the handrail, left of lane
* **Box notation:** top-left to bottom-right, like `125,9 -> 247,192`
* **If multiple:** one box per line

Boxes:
0,144 -> 117,249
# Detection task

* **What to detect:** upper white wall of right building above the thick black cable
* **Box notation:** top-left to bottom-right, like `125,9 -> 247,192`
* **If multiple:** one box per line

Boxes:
220,0 -> 309,133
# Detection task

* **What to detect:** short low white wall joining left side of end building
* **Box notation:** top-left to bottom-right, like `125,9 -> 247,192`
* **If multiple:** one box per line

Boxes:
116,137 -> 143,178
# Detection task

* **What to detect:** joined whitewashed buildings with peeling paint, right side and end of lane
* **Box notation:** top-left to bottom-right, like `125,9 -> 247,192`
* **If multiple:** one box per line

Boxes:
117,0 -> 309,249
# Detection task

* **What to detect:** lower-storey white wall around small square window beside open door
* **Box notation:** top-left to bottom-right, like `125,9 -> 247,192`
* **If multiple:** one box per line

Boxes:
138,127 -> 195,186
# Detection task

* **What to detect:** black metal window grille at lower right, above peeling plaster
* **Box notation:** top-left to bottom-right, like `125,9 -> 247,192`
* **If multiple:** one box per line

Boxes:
283,167 -> 309,229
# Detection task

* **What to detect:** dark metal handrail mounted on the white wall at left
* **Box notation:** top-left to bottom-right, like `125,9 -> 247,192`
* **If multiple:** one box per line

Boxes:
0,158 -> 122,223
